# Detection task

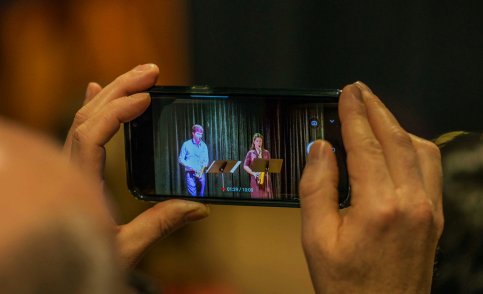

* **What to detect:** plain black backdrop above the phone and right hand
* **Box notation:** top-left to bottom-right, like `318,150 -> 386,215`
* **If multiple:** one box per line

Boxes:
191,0 -> 483,138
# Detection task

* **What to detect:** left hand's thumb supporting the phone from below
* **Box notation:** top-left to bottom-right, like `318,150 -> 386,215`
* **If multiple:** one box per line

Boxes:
116,199 -> 210,267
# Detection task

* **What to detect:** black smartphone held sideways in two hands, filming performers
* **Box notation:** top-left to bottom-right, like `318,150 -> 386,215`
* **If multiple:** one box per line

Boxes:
124,86 -> 350,208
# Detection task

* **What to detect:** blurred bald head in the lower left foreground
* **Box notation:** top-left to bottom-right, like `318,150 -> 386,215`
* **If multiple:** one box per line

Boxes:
0,119 -> 122,293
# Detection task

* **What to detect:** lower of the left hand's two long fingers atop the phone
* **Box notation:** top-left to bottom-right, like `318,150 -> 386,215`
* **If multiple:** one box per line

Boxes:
72,93 -> 151,177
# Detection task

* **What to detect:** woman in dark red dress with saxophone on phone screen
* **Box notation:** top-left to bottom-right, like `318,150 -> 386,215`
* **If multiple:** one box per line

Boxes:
243,133 -> 273,199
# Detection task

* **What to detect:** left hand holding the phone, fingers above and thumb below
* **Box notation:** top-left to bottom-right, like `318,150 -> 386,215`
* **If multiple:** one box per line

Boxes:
64,64 -> 209,267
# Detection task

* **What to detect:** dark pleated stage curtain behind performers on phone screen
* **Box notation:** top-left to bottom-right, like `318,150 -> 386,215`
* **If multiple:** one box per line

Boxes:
153,99 -> 324,199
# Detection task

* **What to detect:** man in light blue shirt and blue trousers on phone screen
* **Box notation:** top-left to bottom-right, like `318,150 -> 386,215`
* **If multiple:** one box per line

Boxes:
178,124 -> 208,197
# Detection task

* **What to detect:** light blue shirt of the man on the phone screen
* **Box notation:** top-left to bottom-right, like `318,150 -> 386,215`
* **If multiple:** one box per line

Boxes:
178,139 -> 209,172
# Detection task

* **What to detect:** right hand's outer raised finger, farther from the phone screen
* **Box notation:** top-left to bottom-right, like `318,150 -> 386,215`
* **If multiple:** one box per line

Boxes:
355,82 -> 422,189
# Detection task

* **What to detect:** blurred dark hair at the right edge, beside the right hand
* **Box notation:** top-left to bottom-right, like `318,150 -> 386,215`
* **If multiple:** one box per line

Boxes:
432,132 -> 483,293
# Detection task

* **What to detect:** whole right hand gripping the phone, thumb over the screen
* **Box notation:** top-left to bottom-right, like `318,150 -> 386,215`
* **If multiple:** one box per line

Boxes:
300,82 -> 444,293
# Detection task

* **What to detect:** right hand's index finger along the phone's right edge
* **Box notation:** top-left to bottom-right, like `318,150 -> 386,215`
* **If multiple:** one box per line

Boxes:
339,85 -> 393,206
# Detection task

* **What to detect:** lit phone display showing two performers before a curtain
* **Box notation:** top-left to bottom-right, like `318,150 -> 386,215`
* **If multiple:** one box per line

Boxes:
152,95 -> 339,201
